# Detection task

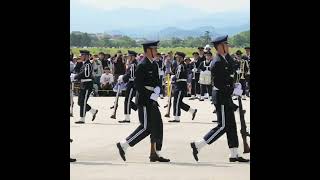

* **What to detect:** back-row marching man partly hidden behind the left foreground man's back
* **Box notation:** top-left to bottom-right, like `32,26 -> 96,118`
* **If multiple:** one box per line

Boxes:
118,50 -> 138,123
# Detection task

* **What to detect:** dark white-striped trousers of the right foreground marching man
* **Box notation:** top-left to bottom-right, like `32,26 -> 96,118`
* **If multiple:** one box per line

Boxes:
203,90 -> 239,148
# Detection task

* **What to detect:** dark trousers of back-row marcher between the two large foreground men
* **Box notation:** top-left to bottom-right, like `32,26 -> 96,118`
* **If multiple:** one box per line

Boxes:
173,89 -> 190,116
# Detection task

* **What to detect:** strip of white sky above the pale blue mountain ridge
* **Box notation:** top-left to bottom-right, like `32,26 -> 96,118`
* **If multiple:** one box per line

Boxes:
73,0 -> 250,13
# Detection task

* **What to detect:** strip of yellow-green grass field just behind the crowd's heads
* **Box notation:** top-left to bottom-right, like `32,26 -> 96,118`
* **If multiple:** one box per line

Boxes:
71,47 -> 245,57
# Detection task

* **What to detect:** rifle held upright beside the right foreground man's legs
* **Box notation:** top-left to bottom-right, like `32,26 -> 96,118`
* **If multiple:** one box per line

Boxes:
238,96 -> 250,153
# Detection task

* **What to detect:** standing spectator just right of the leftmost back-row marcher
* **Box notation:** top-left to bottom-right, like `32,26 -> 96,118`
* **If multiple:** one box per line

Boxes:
92,55 -> 103,96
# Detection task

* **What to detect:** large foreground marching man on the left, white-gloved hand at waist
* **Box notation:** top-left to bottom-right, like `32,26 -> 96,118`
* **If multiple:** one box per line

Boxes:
117,41 -> 170,162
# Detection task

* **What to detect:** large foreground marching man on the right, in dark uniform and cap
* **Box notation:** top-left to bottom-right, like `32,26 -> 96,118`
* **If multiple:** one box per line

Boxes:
191,36 -> 249,162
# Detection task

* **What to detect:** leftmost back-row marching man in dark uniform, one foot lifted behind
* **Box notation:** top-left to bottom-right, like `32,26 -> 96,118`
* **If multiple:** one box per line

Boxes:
74,50 -> 98,124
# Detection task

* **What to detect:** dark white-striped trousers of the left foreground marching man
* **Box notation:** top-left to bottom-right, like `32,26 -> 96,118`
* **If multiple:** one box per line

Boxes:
126,100 -> 163,151
